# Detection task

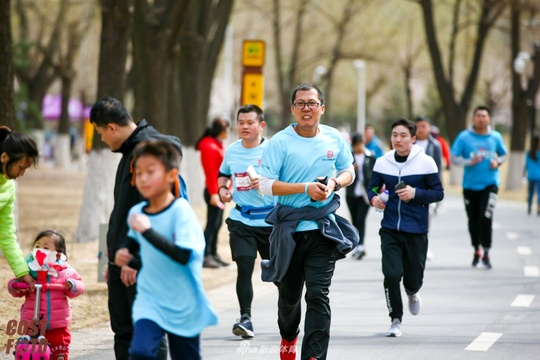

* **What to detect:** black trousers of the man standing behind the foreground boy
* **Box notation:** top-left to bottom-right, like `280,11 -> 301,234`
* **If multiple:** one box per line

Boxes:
107,264 -> 167,360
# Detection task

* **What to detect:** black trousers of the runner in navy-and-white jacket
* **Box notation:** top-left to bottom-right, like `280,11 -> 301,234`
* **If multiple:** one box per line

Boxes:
379,228 -> 428,321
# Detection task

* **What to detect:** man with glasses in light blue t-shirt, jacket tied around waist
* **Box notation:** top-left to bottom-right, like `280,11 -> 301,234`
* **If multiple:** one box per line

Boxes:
259,84 -> 358,360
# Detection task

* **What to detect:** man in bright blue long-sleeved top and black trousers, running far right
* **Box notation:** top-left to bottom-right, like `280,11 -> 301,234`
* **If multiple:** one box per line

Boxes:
450,106 -> 507,269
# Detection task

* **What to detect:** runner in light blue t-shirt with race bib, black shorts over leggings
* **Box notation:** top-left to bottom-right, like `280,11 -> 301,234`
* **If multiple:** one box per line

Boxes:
218,104 -> 276,339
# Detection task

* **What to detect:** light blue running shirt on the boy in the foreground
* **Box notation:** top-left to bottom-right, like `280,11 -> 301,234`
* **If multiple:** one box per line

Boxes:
128,198 -> 217,337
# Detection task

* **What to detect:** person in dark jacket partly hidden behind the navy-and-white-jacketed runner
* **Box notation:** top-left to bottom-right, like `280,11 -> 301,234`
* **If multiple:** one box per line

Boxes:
345,133 -> 375,260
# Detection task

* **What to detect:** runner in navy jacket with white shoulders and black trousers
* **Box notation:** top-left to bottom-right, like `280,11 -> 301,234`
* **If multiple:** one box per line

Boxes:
369,118 -> 444,336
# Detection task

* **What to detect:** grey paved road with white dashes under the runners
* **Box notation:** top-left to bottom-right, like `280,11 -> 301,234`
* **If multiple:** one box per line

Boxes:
50,197 -> 540,360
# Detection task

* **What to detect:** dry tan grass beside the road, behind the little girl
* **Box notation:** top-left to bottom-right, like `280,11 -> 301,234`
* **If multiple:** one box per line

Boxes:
0,169 -> 236,353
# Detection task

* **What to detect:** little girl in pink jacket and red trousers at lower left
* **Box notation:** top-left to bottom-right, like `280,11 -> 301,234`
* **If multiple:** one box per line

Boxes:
8,230 -> 84,360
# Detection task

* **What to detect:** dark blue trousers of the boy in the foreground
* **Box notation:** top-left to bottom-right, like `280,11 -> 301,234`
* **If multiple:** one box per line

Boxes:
129,319 -> 201,360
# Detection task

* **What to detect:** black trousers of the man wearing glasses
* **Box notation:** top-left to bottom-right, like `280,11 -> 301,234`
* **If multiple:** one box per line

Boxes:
278,230 -> 339,360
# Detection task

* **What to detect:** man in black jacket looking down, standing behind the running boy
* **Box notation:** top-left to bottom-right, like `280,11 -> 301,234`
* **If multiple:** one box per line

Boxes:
90,97 -> 182,360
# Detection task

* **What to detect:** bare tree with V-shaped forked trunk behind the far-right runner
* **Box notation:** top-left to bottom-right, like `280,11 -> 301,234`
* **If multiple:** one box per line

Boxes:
418,0 -> 507,141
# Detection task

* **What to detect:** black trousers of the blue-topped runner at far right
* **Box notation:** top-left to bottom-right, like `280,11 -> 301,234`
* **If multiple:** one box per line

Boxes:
463,185 -> 499,250
